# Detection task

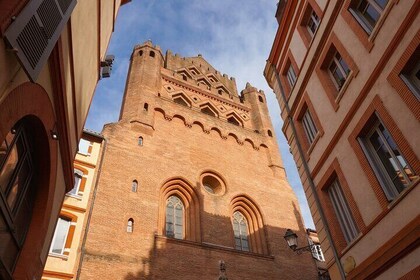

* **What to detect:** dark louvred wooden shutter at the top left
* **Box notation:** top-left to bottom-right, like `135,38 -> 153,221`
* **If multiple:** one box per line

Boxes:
4,0 -> 77,82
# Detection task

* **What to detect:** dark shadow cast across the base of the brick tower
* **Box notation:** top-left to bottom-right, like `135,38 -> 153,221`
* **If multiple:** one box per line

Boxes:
118,208 -> 317,280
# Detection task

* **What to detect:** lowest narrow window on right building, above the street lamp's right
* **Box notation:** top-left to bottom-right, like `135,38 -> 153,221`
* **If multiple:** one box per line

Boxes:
328,179 -> 359,244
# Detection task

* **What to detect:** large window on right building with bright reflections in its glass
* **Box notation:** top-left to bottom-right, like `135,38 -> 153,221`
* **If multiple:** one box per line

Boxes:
358,120 -> 418,201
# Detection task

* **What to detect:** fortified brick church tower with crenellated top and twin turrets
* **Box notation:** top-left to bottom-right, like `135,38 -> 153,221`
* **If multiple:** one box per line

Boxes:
79,41 -> 316,279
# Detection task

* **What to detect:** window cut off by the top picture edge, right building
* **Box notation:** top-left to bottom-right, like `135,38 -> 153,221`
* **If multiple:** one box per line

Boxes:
349,0 -> 388,34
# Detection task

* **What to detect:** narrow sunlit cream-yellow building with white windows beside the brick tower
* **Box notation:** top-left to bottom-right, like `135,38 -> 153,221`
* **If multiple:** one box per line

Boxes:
42,130 -> 103,280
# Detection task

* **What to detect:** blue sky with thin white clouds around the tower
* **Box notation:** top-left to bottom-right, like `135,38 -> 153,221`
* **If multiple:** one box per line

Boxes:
86,0 -> 314,228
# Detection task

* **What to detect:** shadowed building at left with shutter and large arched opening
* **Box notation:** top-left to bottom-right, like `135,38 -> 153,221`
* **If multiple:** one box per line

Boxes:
0,0 -> 129,280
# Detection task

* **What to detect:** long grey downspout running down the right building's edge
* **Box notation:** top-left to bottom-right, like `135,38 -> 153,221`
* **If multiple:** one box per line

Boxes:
270,64 -> 346,279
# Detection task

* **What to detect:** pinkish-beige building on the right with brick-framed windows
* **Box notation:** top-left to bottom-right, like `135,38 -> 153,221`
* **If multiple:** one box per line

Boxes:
264,0 -> 420,279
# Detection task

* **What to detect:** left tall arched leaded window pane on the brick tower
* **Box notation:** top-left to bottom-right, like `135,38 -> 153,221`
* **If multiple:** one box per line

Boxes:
165,195 -> 184,239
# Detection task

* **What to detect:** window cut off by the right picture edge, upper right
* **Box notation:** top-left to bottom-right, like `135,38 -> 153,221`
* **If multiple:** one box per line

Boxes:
400,46 -> 420,101
